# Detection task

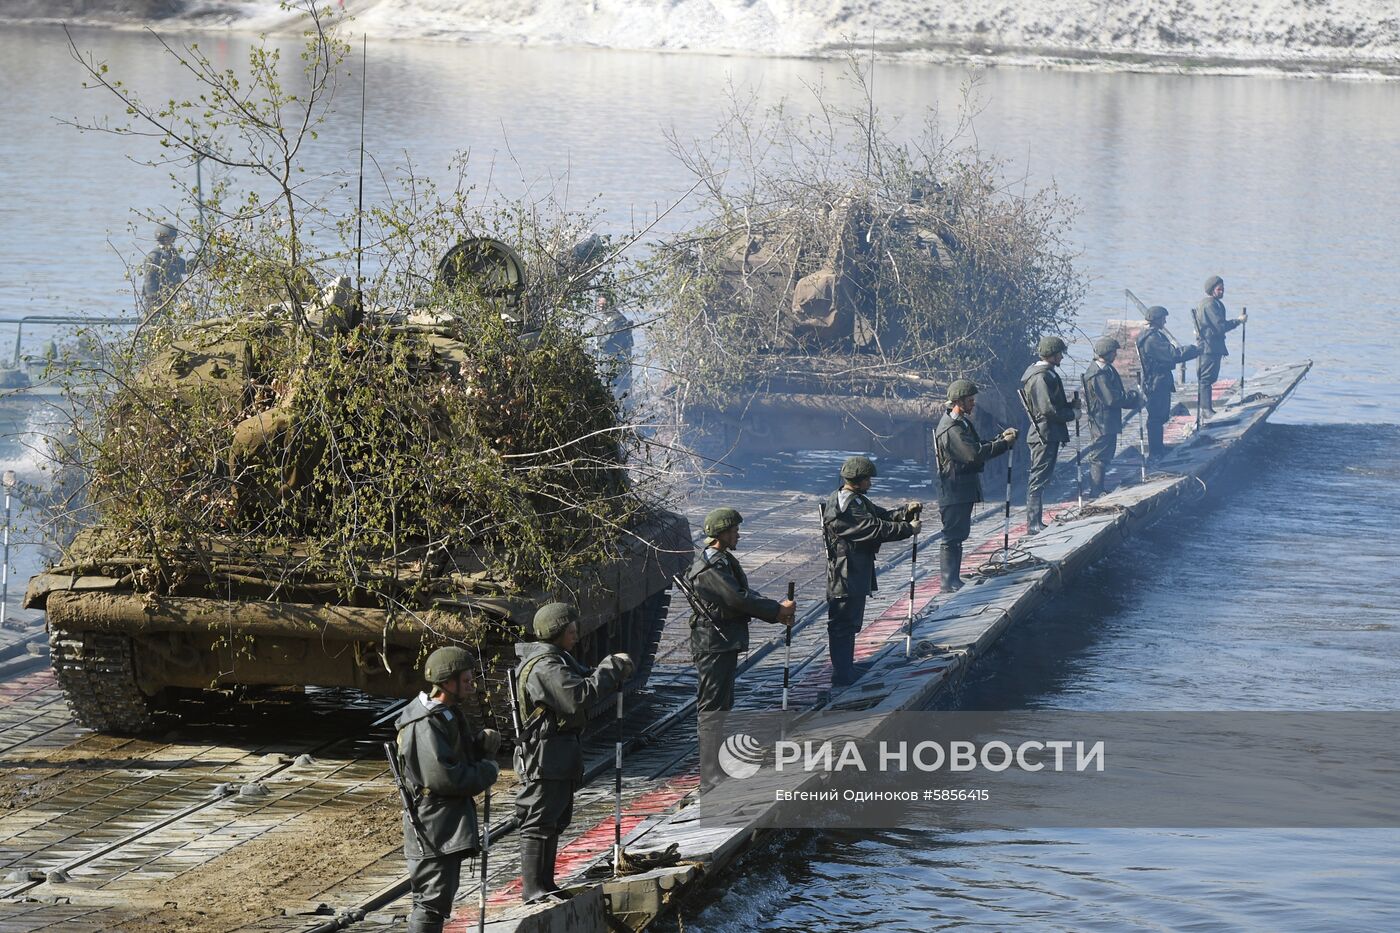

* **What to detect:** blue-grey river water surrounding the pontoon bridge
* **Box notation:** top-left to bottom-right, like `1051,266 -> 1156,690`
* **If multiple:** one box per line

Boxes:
0,21 -> 1400,930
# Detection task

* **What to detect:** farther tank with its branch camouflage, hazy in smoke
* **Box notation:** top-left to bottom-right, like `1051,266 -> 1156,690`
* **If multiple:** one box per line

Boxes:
655,190 -> 1019,462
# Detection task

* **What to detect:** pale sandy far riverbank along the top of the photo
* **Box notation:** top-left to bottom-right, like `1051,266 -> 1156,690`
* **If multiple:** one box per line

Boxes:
0,0 -> 1400,80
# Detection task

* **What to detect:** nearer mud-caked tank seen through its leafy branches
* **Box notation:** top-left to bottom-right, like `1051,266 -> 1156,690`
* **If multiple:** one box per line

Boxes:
25,241 -> 692,734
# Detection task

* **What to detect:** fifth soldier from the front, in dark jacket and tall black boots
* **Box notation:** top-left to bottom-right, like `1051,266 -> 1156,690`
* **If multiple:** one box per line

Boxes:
934,380 -> 1016,593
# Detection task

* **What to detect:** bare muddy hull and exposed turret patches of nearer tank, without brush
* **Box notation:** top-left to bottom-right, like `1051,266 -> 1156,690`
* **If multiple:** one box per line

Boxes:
25,241 -> 692,735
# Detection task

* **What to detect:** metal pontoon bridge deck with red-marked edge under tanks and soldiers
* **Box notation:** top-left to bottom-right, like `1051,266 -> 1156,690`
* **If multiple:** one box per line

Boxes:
0,363 -> 1310,933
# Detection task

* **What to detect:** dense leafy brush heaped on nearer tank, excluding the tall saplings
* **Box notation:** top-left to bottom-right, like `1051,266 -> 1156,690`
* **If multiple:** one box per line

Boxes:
49,198 -> 645,602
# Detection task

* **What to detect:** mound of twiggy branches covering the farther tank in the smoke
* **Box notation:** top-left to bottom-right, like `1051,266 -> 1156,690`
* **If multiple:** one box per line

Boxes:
654,80 -> 1085,411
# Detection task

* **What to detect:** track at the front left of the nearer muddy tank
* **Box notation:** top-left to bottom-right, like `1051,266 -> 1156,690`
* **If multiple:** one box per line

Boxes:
49,629 -> 160,735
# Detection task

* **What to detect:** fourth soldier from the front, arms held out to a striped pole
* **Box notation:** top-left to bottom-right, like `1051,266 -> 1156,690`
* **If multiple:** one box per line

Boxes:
822,457 -> 924,686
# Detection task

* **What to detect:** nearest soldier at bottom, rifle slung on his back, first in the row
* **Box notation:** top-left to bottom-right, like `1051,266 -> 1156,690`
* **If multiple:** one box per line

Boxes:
395,647 -> 501,933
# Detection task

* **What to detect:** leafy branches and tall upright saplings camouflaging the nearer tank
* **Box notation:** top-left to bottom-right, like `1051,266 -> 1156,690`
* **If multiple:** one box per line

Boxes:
55,6 -> 652,607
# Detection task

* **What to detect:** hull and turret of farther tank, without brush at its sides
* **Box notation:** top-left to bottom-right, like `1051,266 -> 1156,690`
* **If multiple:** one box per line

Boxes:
658,182 -> 1016,464
